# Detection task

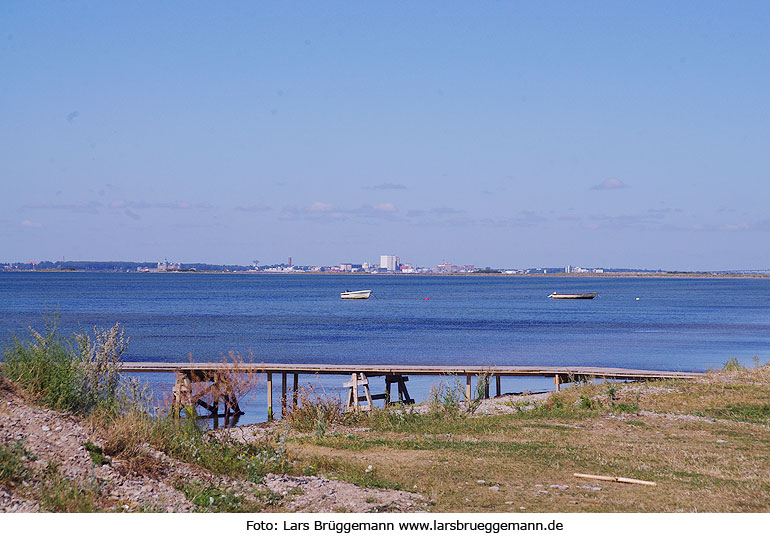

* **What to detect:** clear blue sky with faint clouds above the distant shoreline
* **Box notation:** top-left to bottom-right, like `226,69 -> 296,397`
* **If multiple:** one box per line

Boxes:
0,0 -> 770,270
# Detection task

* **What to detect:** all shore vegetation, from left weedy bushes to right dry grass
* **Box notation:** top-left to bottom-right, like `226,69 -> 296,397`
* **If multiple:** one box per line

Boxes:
0,318 -> 770,512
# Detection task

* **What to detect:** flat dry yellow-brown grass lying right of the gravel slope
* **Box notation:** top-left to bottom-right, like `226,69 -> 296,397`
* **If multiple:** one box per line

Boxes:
280,367 -> 770,512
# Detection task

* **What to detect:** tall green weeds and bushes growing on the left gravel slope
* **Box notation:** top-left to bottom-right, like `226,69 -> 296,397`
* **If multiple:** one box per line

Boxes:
0,318 -> 290,512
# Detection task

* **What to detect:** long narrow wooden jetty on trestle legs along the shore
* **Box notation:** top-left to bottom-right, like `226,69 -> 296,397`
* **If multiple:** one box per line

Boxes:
122,362 -> 698,420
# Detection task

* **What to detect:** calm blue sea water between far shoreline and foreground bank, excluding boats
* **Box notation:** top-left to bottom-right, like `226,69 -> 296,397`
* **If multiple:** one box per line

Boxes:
0,273 -> 770,420
